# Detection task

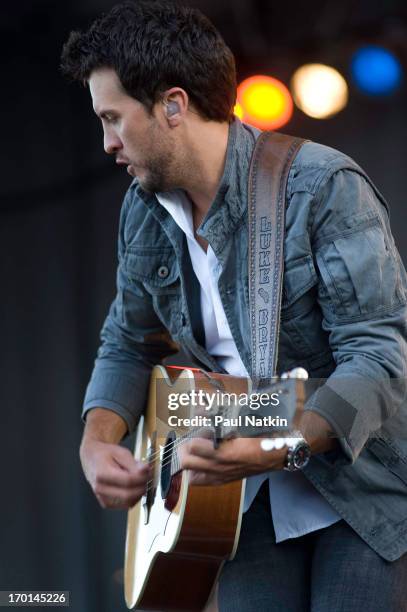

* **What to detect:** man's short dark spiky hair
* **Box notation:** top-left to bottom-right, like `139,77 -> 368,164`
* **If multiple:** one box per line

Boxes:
61,0 -> 236,121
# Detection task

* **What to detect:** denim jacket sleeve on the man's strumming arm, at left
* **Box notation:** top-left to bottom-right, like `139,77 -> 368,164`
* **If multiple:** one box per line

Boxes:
82,190 -> 178,433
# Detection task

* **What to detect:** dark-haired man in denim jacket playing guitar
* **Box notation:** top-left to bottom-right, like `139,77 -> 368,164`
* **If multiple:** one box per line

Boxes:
62,2 -> 407,612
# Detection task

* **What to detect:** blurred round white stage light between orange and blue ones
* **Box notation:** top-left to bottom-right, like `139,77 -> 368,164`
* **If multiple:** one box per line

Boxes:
291,64 -> 349,119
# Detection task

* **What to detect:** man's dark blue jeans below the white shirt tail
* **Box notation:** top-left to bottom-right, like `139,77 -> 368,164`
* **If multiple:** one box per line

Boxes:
218,482 -> 407,612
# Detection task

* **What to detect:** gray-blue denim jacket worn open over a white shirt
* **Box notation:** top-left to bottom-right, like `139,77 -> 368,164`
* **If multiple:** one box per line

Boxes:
84,120 -> 407,560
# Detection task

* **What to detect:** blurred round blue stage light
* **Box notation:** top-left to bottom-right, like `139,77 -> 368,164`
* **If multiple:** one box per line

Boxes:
351,45 -> 402,95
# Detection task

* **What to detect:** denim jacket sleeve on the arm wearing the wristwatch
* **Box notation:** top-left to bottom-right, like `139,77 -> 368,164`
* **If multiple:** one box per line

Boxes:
305,169 -> 407,464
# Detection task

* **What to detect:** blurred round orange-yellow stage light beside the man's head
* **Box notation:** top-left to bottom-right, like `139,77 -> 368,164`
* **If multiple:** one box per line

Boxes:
237,75 -> 294,130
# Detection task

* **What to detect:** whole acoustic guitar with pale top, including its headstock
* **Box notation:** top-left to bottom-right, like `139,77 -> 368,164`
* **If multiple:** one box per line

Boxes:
125,366 -> 305,612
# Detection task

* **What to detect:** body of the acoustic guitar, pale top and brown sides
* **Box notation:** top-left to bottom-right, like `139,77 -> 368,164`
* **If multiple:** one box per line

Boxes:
125,366 -> 250,612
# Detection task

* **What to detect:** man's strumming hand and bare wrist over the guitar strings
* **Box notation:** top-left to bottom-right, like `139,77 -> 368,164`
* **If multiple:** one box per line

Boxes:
80,408 -> 151,510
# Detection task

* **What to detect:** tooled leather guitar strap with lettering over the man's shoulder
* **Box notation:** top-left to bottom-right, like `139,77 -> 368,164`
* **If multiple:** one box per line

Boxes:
249,132 -> 306,391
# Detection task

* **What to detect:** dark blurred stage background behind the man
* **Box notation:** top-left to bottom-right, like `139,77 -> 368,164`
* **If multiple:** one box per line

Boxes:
0,0 -> 407,612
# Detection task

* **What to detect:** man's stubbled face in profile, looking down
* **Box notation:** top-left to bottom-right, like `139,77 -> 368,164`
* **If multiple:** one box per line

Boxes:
89,68 -> 177,193
